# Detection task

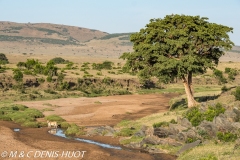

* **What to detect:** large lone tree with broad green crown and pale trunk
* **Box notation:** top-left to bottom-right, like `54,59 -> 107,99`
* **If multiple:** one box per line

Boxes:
120,15 -> 234,107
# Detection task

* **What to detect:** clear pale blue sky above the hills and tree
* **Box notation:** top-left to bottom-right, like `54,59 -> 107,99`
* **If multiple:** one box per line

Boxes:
0,0 -> 240,45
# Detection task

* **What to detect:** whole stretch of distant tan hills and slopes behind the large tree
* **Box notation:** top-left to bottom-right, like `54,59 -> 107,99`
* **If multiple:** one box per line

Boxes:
0,21 -> 240,61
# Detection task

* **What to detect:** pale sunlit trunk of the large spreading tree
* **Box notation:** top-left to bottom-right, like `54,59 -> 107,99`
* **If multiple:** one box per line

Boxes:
183,73 -> 198,108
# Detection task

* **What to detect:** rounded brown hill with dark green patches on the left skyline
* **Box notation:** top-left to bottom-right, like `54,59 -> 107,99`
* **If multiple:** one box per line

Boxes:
0,22 -> 108,45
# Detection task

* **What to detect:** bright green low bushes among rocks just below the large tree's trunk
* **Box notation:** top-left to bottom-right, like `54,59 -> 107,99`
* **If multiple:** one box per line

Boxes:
184,103 -> 226,126
